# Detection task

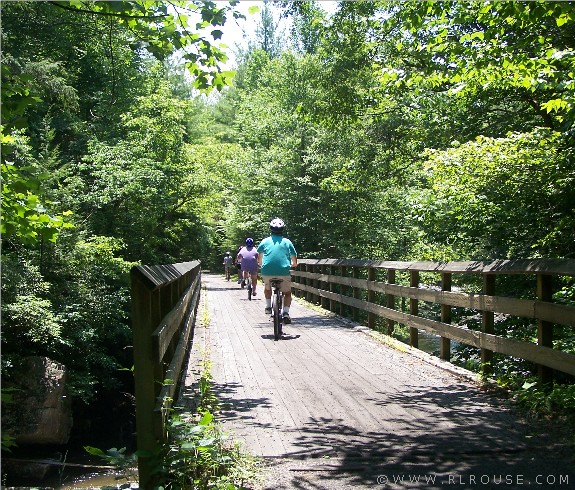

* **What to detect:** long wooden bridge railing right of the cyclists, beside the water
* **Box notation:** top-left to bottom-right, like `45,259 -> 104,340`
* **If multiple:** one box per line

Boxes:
292,259 -> 575,382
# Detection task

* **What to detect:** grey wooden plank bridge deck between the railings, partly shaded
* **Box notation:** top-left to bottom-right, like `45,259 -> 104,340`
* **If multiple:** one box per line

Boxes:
180,274 -> 575,489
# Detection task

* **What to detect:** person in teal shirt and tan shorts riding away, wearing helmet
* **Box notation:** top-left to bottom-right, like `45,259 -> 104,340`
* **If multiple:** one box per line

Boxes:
257,218 -> 297,325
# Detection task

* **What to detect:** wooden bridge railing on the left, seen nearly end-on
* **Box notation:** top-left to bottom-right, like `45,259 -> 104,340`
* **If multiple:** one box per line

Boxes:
131,261 -> 201,489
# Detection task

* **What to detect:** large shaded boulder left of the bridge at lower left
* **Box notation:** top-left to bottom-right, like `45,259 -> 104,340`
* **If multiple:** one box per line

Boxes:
2,357 -> 72,446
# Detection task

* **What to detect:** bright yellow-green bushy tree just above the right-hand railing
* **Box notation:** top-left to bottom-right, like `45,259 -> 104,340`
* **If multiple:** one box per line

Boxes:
413,128 -> 575,260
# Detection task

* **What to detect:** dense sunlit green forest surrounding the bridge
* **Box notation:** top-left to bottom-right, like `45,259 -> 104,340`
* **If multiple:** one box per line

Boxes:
1,0 -> 575,456
